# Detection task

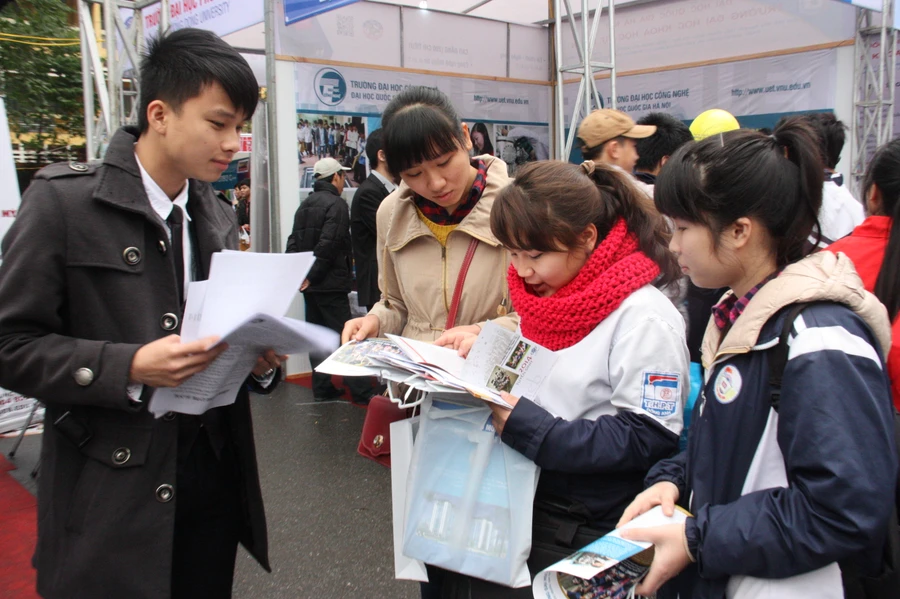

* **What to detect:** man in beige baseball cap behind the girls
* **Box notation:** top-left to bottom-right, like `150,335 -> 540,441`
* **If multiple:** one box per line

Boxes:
578,108 -> 656,173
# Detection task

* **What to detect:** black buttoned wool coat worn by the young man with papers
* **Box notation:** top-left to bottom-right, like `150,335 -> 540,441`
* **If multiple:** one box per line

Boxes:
0,128 -> 269,599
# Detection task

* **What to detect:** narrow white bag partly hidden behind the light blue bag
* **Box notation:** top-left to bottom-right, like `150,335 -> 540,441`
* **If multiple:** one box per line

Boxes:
391,416 -> 428,582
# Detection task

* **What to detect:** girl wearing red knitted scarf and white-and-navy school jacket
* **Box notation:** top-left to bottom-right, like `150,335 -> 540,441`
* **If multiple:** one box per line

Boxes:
439,161 -> 689,598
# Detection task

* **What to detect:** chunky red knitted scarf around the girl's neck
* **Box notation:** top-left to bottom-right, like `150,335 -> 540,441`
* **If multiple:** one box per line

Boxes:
507,219 -> 659,351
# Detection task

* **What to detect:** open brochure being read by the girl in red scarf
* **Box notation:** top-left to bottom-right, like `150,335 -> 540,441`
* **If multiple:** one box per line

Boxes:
316,322 -> 557,407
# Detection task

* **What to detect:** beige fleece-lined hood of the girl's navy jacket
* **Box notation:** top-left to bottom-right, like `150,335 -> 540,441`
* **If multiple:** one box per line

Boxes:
701,252 -> 891,370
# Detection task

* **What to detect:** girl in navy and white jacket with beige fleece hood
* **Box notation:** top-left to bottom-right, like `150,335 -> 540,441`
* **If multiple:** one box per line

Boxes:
620,119 -> 897,599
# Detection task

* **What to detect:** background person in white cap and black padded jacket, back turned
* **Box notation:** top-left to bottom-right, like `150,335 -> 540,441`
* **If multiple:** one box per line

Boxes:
285,158 -> 371,401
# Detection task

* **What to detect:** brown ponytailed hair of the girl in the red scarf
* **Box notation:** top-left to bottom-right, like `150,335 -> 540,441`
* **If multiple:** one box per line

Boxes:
491,160 -> 681,285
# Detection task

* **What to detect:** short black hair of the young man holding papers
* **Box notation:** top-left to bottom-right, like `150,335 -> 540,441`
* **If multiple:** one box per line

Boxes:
138,28 -> 259,133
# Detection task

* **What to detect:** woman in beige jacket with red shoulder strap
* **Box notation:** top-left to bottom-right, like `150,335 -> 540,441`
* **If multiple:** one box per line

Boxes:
342,87 -> 518,342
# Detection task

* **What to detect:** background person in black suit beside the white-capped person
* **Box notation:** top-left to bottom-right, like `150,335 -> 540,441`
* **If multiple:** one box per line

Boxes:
350,129 -> 397,311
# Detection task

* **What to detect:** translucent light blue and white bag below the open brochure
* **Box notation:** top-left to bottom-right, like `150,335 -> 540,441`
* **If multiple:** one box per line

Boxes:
404,400 -> 538,588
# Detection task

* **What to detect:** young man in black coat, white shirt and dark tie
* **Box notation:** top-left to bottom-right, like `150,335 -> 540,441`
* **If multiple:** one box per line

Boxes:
0,29 -> 283,599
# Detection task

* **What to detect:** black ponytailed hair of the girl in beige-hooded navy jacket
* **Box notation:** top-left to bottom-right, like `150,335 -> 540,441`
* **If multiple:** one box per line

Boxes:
654,116 -> 825,267
